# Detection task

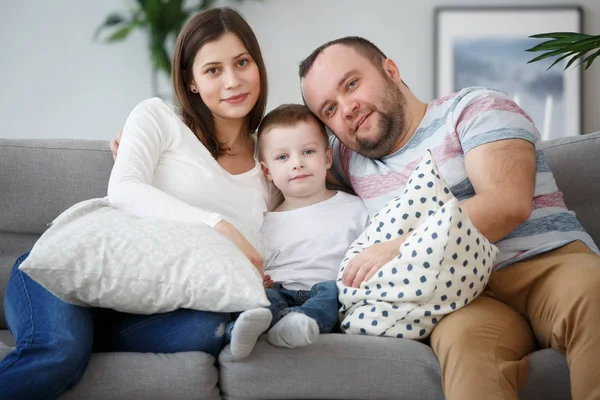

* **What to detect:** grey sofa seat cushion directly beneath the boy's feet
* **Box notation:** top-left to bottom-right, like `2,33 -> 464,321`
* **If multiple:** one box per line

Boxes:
219,334 -> 444,400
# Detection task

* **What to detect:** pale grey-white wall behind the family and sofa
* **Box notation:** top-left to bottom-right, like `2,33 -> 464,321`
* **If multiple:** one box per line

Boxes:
0,0 -> 600,139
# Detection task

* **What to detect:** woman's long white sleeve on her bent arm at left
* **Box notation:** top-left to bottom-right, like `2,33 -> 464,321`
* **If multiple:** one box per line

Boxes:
108,98 -> 223,227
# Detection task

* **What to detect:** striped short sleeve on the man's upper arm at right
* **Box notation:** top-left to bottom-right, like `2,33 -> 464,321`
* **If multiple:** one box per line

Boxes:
452,89 -> 540,154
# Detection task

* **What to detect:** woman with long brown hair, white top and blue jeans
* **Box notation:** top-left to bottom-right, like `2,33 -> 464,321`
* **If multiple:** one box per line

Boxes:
0,8 -> 272,399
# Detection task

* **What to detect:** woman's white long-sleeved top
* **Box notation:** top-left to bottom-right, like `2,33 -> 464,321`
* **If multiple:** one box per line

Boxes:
108,98 -> 278,231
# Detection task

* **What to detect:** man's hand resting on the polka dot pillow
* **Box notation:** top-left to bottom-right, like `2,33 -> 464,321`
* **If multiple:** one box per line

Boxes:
342,234 -> 408,288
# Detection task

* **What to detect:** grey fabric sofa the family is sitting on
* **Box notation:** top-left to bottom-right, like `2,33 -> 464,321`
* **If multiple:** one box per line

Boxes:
0,133 -> 600,400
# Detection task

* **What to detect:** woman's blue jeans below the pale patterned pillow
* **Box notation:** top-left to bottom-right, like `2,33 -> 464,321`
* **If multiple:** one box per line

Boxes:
0,253 -> 231,400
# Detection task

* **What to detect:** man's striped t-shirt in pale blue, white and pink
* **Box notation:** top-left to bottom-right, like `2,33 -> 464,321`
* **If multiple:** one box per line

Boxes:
330,88 -> 600,268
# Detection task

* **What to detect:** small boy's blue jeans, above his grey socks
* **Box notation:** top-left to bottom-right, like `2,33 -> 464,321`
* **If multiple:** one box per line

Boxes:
227,281 -> 340,341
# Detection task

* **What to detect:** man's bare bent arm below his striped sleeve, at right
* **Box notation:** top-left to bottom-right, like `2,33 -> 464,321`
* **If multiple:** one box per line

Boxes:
461,139 -> 536,243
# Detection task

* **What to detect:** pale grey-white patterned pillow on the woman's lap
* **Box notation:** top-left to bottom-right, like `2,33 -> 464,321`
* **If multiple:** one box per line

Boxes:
19,199 -> 271,314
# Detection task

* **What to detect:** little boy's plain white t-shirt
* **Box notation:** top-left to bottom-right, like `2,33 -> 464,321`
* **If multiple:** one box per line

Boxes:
261,192 -> 369,290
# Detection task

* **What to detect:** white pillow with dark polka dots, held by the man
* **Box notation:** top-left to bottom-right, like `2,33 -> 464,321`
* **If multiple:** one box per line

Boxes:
337,152 -> 498,339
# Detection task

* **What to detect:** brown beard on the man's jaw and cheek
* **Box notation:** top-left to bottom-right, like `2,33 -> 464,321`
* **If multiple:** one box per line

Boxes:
353,76 -> 406,158
